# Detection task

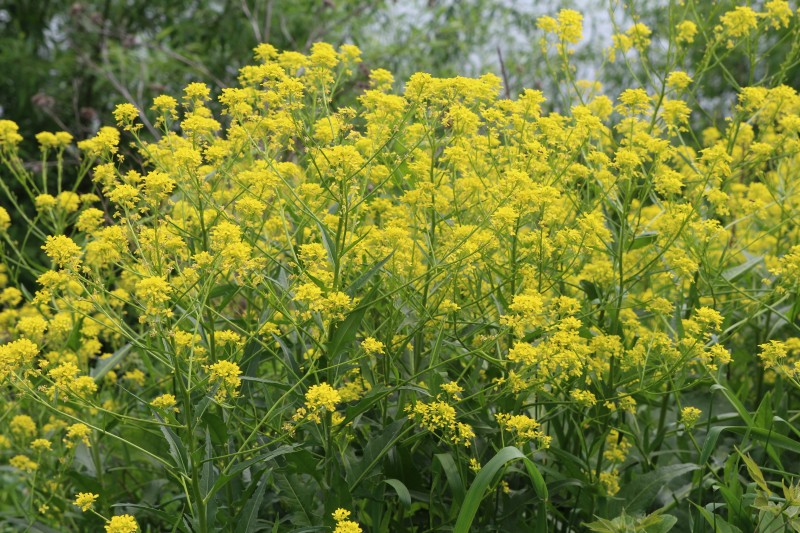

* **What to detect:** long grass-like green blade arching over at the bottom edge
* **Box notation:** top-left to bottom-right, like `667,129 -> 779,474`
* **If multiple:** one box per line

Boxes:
453,446 -> 547,533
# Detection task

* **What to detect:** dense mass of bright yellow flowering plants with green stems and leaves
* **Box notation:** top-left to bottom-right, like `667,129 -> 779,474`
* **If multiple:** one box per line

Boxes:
0,0 -> 800,533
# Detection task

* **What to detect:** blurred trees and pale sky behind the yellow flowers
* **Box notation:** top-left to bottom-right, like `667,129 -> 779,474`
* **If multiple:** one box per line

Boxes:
0,0 -> 800,148
